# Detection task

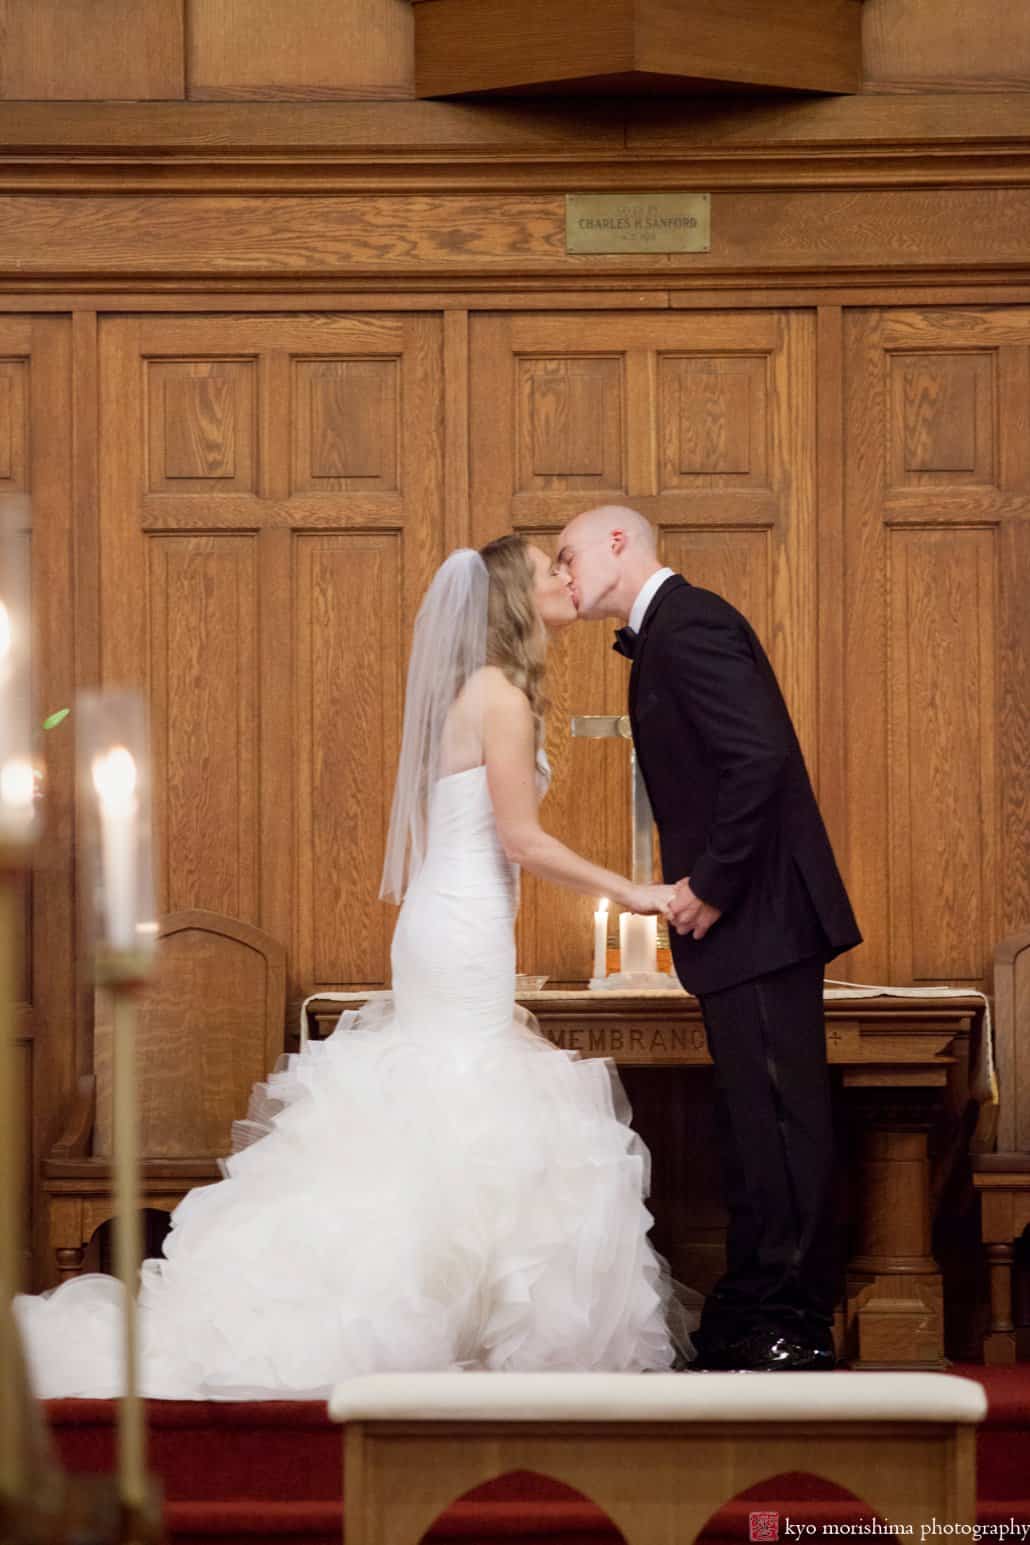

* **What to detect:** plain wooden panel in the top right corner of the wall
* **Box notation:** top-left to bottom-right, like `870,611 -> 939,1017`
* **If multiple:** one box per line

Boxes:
862,0 -> 1030,91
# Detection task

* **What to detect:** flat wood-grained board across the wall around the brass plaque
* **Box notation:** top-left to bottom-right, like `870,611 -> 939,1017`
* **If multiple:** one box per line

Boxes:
0,188 -> 1030,283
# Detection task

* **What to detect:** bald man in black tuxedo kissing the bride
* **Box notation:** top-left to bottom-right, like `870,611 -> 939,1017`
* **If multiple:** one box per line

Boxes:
559,505 -> 862,1370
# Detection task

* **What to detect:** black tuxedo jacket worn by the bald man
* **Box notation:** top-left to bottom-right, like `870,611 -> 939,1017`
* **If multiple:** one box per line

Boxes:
630,575 -> 862,995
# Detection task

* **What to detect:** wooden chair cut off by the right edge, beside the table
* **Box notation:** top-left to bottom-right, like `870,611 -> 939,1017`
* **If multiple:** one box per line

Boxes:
971,933 -> 1030,1364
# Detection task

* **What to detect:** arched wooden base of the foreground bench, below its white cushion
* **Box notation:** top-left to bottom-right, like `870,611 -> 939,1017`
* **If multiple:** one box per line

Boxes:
344,1415 -> 976,1545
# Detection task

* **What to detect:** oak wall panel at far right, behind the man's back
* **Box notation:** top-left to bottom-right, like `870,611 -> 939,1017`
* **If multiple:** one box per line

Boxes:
845,309 -> 1030,987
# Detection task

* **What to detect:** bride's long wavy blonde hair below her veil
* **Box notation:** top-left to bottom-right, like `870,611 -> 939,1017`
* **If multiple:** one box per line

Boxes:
479,536 -> 547,746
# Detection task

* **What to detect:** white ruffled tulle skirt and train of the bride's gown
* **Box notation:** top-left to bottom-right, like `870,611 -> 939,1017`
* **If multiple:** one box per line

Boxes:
15,1000 -> 701,1400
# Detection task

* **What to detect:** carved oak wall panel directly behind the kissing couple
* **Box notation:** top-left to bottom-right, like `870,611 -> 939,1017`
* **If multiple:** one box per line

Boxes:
469,312 -> 817,983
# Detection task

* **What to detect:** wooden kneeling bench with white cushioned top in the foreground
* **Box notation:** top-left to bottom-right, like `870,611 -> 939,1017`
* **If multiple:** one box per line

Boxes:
329,1372 -> 987,1545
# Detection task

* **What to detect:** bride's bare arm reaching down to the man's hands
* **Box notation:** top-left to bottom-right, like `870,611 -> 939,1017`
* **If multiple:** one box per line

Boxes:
483,669 -> 673,912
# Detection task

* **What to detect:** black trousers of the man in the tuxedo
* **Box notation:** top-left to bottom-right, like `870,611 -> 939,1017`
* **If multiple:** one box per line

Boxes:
698,956 -> 839,1344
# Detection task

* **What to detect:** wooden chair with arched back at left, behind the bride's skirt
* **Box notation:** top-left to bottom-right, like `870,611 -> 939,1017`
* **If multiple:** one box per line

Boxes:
42,912 -> 286,1281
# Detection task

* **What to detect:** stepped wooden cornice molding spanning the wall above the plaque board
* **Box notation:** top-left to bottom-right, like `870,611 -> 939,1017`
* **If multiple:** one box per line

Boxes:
0,93 -> 1030,198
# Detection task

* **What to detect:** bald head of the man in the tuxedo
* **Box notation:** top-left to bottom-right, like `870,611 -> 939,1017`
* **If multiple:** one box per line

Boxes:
557,504 -> 658,620
